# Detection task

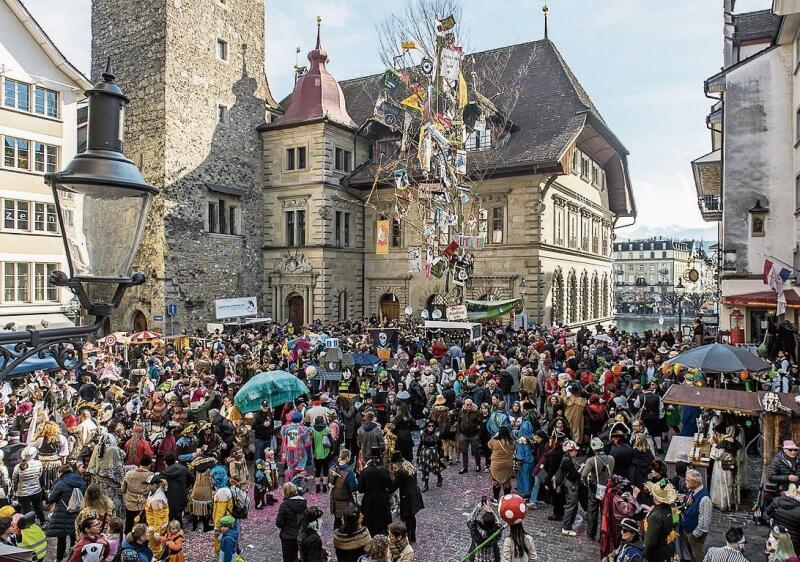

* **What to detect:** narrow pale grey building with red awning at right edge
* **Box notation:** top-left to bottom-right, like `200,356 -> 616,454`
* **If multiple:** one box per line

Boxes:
692,0 -> 800,343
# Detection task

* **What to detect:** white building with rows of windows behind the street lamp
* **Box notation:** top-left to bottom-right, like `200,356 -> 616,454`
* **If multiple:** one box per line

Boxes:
0,0 -> 91,330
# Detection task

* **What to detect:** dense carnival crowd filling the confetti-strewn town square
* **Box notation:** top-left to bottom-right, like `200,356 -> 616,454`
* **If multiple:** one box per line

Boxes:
0,319 -> 800,562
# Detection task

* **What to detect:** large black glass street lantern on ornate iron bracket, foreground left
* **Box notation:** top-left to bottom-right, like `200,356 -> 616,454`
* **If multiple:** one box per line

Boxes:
0,58 -> 158,381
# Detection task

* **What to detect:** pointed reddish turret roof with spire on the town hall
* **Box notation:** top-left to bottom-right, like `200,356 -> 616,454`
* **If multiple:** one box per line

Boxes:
269,18 -> 356,128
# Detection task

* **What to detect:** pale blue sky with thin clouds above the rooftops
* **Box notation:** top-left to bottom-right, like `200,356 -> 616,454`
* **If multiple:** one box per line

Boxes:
23,0 -> 771,239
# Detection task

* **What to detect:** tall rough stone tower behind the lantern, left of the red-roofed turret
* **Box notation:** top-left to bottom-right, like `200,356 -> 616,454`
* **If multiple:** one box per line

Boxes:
92,0 -> 277,333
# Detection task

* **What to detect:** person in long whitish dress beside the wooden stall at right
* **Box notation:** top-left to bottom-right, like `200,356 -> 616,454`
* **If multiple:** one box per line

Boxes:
709,414 -> 741,511
